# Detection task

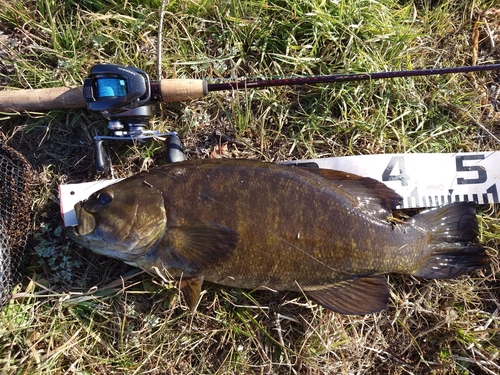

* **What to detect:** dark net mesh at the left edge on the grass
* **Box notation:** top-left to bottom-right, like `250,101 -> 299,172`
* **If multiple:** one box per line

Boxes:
0,143 -> 33,310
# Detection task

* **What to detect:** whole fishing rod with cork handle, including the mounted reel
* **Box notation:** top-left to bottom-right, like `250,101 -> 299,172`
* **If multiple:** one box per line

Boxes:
0,64 -> 500,171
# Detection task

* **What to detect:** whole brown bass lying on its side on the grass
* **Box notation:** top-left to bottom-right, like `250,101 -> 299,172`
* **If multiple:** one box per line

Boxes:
70,159 -> 489,315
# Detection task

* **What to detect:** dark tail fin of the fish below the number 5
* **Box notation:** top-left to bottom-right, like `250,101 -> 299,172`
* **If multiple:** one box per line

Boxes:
413,202 -> 489,279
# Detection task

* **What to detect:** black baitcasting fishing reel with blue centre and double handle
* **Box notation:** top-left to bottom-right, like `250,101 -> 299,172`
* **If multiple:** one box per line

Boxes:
83,64 -> 184,171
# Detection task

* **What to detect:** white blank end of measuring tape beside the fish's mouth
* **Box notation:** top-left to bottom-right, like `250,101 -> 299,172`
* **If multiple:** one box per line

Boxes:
59,178 -> 123,227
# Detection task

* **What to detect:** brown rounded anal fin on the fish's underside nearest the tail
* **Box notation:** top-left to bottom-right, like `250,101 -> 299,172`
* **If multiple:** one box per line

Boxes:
304,276 -> 389,315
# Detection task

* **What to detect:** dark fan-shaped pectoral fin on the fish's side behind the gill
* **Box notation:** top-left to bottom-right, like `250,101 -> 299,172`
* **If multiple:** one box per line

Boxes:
166,223 -> 239,273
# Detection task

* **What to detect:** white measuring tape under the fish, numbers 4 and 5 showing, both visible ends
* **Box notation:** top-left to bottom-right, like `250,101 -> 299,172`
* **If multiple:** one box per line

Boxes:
59,151 -> 500,226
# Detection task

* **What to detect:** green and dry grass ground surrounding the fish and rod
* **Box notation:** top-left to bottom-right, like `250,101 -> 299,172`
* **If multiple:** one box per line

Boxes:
0,0 -> 500,375
